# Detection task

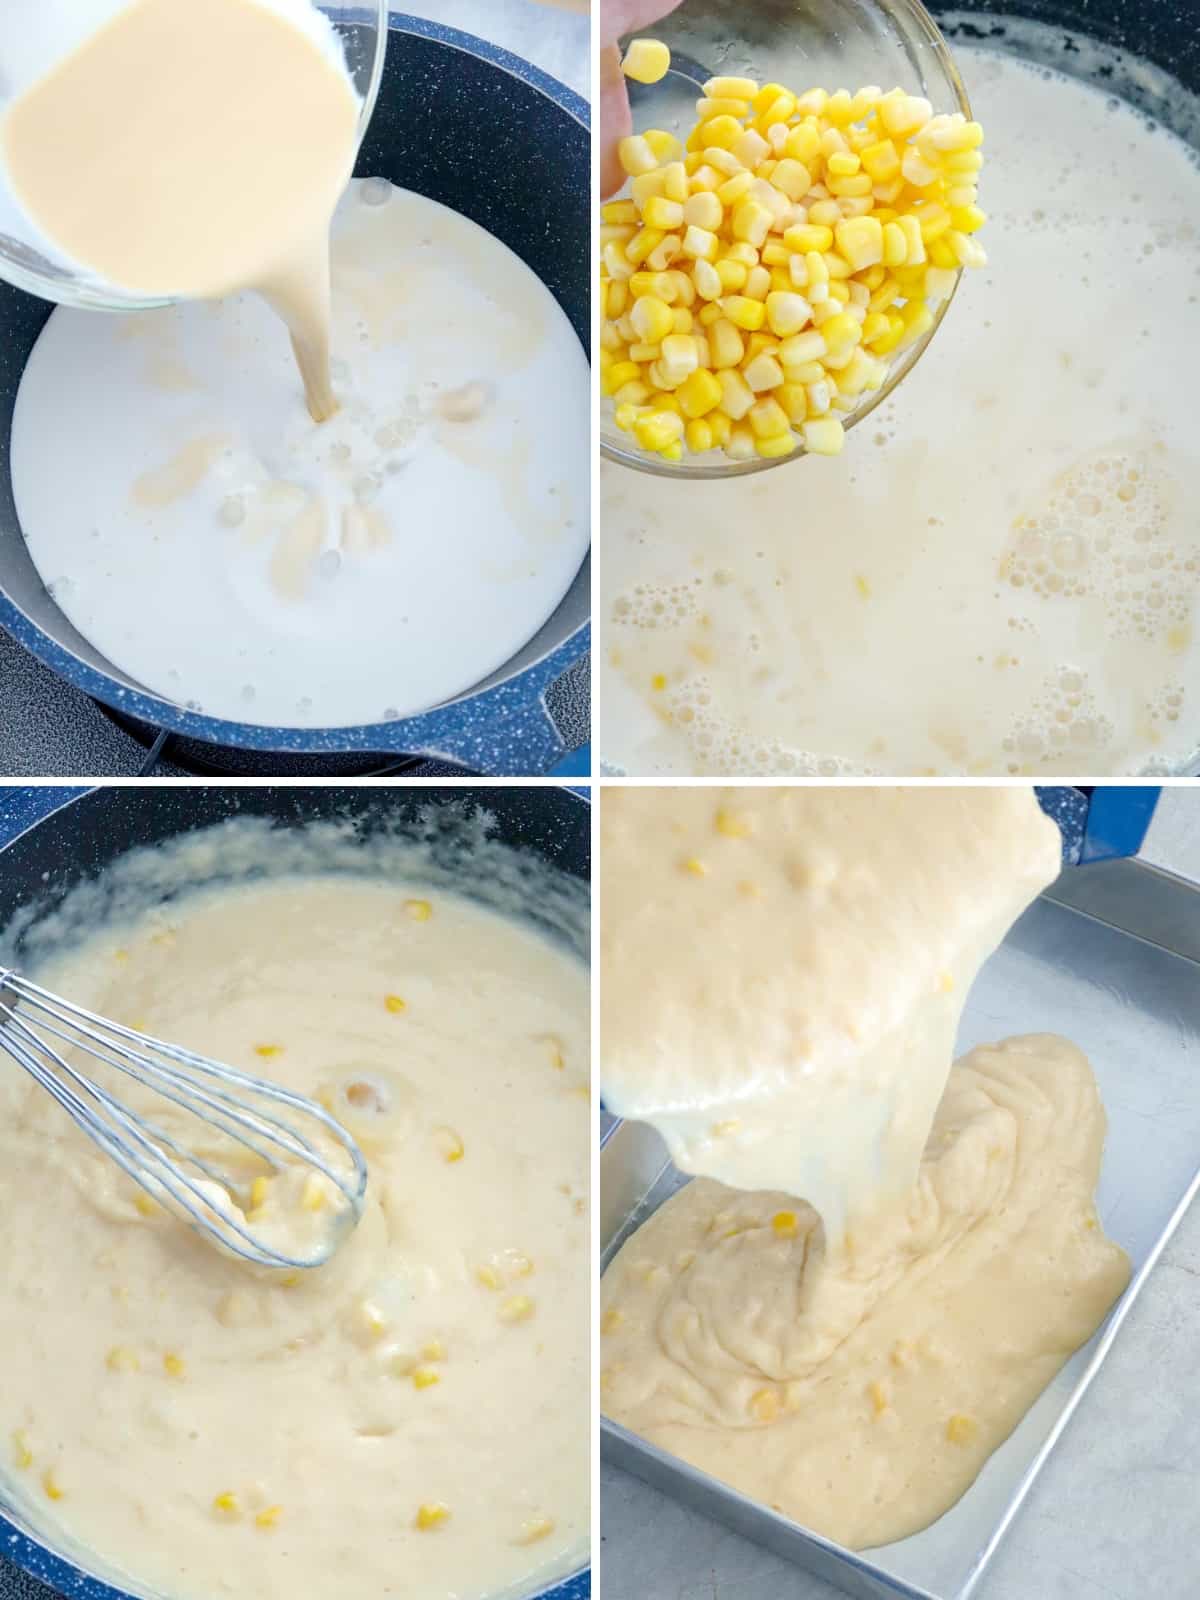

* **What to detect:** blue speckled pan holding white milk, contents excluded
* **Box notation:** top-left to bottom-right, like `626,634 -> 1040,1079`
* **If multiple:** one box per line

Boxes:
0,14 -> 590,776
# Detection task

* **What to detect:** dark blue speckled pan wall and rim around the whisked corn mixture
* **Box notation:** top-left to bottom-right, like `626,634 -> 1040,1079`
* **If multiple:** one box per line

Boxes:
0,784 -> 592,1600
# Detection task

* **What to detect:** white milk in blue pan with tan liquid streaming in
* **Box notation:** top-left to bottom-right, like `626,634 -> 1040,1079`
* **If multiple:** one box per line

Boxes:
13,179 -> 589,726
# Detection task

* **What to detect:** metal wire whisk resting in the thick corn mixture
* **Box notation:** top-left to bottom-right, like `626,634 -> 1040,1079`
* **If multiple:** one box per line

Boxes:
0,968 -> 366,1267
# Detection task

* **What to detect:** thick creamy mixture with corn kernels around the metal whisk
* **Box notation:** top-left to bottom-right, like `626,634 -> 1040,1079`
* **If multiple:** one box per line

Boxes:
0,874 -> 590,1600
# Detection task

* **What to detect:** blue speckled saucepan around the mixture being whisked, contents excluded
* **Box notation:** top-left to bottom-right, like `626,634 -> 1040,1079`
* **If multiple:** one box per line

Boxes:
0,786 -> 590,1600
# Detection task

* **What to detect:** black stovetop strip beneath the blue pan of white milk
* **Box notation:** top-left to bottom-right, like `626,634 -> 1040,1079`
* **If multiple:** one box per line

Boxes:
94,701 -> 477,778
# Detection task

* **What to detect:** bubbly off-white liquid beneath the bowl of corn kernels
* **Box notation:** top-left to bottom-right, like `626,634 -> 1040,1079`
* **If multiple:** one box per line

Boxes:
602,50 -> 1200,774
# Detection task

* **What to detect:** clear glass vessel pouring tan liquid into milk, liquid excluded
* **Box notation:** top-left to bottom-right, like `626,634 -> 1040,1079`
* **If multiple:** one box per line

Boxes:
0,0 -> 387,312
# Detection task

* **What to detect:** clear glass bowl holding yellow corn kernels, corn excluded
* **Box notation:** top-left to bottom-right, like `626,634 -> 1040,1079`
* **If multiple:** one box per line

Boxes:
600,0 -> 971,478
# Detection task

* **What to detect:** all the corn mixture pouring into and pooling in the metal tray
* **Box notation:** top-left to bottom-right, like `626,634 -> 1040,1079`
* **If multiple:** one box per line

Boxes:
600,787 -> 1128,1547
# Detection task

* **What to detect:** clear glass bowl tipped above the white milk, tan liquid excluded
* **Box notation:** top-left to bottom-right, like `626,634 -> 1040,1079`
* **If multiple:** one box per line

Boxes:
0,0 -> 387,312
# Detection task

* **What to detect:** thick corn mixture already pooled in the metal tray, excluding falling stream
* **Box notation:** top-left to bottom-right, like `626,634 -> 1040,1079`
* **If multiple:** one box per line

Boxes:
600,1035 -> 1130,1549
